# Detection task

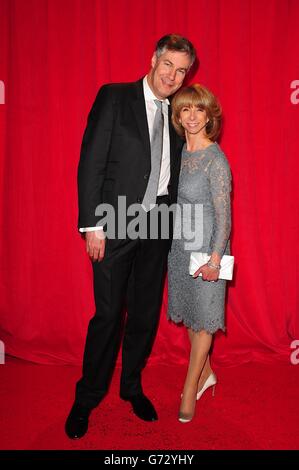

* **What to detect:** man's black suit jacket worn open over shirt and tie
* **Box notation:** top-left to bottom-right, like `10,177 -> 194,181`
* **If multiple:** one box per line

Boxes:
78,79 -> 182,228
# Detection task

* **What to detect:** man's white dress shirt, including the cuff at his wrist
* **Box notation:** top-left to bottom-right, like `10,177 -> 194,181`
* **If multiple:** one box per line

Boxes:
79,75 -> 170,232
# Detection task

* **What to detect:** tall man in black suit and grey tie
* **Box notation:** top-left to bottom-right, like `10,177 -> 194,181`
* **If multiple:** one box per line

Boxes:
65,34 -> 195,438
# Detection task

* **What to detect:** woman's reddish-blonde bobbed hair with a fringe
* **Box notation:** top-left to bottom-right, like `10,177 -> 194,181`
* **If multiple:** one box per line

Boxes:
171,83 -> 222,140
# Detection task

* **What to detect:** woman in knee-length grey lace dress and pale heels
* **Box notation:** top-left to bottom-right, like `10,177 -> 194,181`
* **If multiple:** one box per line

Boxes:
168,84 -> 231,423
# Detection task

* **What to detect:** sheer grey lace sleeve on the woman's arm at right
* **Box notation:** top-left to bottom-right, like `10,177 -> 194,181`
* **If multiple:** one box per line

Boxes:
210,156 -> 231,256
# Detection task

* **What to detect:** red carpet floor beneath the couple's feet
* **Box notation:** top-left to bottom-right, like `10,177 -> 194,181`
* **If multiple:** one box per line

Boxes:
0,357 -> 299,450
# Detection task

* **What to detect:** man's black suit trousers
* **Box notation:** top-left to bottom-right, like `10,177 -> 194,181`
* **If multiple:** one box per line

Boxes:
76,200 -> 170,408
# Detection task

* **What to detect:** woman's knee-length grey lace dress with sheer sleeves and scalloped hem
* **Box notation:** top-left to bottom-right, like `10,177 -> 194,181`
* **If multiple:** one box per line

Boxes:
167,143 -> 231,334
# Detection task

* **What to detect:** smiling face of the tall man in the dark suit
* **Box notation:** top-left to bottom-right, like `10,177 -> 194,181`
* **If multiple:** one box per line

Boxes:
148,50 -> 191,100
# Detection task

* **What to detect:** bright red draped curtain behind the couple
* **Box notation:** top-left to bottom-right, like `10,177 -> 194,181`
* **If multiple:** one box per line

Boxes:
0,0 -> 299,365
